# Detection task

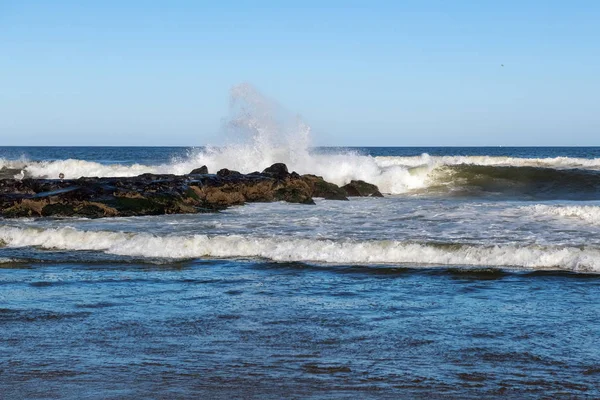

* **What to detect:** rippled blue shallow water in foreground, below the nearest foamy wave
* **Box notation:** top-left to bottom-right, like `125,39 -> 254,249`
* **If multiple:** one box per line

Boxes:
0,260 -> 600,399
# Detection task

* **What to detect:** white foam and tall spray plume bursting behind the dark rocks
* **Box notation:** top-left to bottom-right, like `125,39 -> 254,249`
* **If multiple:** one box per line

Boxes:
2,84 -> 431,193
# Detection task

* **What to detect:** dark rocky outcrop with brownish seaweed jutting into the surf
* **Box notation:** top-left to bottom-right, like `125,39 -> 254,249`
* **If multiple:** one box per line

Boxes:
0,164 -> 381,218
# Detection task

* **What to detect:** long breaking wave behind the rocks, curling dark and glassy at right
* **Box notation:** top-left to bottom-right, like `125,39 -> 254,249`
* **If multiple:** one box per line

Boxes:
0,155 -> 600,199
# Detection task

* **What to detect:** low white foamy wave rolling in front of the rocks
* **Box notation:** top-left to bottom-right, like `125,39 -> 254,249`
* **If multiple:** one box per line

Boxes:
0,227 -> 600,272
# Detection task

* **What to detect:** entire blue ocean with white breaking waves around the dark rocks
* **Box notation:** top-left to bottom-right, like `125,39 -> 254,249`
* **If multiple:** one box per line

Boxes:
0,145 -> 600,399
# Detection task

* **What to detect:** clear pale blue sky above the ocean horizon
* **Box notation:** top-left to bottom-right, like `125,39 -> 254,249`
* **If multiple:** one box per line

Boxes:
0,0 -> 600,146
